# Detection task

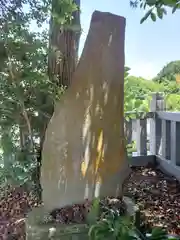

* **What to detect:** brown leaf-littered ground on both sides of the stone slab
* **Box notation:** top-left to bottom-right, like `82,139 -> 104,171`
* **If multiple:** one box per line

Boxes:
0,166 -> 180,240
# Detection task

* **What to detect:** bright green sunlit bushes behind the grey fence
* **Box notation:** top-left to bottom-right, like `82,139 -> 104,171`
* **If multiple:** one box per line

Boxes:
124,66 -> 180,113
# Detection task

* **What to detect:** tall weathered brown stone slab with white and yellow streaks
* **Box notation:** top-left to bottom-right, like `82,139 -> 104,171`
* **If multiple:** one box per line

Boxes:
41,11 -> 129,210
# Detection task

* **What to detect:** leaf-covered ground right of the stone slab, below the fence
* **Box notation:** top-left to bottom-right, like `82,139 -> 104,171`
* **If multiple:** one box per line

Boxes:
124,164 -> 180,235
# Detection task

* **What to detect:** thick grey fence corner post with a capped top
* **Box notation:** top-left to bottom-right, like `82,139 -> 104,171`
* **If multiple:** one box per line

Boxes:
150,93 -> 165,155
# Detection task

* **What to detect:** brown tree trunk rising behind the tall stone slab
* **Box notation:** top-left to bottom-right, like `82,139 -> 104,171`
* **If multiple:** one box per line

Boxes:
36,0 -> 80,202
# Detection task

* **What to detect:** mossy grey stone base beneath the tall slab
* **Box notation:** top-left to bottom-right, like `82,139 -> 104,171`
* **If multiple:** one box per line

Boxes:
26,197 -> 137,240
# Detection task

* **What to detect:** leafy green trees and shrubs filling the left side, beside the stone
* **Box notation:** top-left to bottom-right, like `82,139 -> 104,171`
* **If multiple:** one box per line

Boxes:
0,0 -> 78,188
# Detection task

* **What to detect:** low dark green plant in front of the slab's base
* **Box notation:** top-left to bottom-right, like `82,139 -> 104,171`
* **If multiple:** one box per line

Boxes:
88,201 -> 168,240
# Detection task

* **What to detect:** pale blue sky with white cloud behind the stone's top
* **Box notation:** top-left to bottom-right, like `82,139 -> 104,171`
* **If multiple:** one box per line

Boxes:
80,0 -> 180,79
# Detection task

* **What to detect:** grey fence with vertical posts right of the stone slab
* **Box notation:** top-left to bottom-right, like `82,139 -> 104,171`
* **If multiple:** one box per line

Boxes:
125,93 -> 180,179
